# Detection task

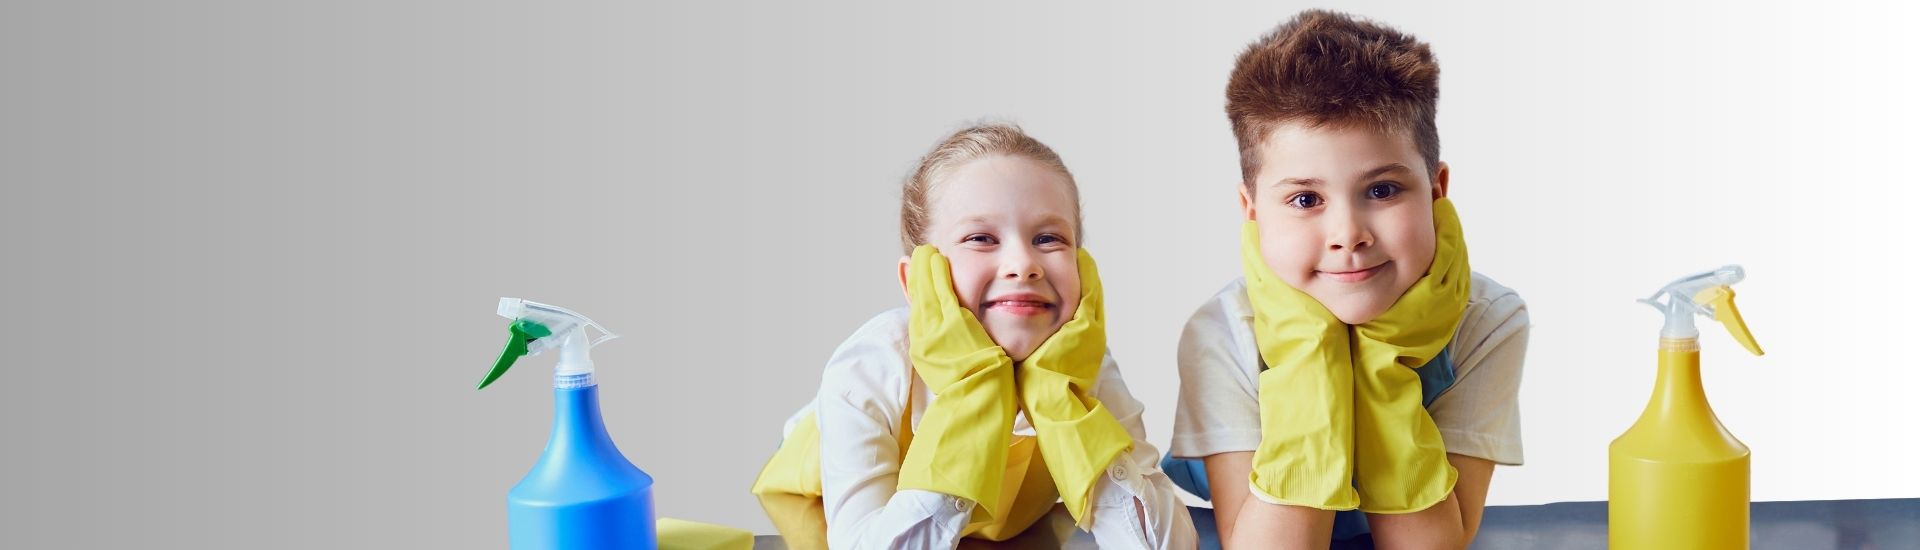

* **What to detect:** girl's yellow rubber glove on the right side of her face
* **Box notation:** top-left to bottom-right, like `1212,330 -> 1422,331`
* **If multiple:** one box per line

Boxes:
1016,248 -> 1133,527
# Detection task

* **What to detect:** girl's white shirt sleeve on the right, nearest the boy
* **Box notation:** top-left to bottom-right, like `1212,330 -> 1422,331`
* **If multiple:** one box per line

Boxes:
1089,354 -> 1198,548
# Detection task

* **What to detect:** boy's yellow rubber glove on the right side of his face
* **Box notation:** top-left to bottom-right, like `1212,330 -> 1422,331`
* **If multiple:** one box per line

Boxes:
1354,198 -> 1473,513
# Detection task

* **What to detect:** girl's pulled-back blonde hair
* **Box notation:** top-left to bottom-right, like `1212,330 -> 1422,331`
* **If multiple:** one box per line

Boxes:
900,123 -> 1085,254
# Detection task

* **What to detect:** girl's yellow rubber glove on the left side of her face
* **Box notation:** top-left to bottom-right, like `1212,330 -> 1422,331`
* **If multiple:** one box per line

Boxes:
899,244 -> 1016,519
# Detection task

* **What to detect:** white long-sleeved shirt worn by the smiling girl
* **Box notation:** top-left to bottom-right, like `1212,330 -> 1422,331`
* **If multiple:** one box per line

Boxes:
787,308 -> 1198,548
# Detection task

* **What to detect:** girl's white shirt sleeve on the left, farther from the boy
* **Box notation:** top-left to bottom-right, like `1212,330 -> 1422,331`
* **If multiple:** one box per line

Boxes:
816,310 -> 973,550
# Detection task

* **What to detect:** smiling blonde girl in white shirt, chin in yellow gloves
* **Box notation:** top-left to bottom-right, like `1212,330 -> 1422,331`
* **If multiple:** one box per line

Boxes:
755,125 -> 1196,548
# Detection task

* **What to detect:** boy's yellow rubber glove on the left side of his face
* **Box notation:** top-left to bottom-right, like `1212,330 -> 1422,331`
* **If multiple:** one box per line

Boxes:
1240,221 -> 1359,510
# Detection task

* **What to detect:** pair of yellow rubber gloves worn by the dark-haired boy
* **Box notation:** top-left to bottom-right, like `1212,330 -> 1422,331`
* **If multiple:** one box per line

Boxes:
1240,198 -> 1471,513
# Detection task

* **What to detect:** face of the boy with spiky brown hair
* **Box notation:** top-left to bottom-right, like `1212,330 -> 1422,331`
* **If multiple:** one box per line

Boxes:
1240,123 -> 1448,325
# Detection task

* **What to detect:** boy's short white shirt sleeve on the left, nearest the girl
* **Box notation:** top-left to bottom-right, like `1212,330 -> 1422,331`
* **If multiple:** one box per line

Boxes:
1173,281 -> 1260,458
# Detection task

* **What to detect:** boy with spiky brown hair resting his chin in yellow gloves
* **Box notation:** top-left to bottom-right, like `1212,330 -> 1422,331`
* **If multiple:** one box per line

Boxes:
1171,10 -> 1528,548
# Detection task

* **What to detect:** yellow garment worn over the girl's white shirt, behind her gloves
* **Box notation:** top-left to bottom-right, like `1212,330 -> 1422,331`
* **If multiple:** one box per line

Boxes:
753,403 -> 1060,548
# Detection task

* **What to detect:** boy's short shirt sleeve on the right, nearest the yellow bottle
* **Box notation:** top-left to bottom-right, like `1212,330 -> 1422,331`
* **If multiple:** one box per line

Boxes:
1427,273 -> 1532,465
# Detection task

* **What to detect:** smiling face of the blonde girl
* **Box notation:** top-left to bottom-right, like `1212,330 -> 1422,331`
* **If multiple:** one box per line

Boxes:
900,156 -> 1079,362
